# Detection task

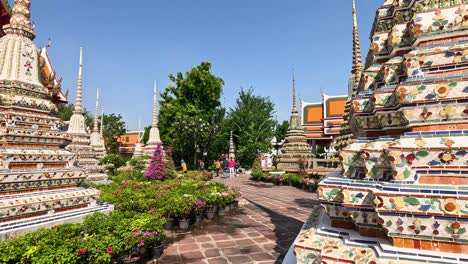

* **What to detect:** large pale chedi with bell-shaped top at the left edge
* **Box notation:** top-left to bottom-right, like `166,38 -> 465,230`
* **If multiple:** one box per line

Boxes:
0,0 -> 110,240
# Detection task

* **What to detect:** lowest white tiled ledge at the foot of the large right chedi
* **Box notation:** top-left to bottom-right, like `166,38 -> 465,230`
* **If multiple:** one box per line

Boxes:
294,206 -> 468,264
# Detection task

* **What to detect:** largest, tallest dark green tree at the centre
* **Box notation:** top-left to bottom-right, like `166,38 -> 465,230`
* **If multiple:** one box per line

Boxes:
159,62 -> 225,166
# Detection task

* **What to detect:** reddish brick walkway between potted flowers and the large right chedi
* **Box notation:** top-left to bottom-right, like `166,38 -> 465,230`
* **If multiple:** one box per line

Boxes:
158,175 -> 317,264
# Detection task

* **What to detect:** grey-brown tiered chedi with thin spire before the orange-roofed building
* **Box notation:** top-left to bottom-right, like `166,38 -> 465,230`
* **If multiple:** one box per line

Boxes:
278,74 -> 312,172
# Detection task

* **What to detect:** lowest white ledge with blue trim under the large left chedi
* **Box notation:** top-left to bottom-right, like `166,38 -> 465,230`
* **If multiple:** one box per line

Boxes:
0,196 -> 114,241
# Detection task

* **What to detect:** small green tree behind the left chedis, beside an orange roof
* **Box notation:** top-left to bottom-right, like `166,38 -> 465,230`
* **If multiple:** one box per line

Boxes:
103,113 -> 127,153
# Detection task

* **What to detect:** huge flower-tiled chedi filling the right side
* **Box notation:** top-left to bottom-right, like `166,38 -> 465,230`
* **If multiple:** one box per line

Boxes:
295,0 -> 468,263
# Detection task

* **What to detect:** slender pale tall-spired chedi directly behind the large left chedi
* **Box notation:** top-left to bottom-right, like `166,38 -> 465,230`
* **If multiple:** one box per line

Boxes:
66,49 -> 107,183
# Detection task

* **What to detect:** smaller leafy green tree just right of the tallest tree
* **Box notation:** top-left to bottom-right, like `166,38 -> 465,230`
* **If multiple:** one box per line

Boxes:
224,88 -> 276,167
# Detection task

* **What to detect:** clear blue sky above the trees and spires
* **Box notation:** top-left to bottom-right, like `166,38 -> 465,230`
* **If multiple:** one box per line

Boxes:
26,0 -> 383,130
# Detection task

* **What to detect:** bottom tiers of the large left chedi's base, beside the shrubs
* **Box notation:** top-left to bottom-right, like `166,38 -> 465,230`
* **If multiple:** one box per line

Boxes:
0,187 -> 113,241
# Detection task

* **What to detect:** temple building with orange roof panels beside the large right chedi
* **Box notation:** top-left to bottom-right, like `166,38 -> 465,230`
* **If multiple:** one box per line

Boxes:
301,94 -> 348,154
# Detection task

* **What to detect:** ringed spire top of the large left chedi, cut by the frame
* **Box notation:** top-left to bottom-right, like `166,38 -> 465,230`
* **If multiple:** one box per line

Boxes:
3,0 -> 36,40
